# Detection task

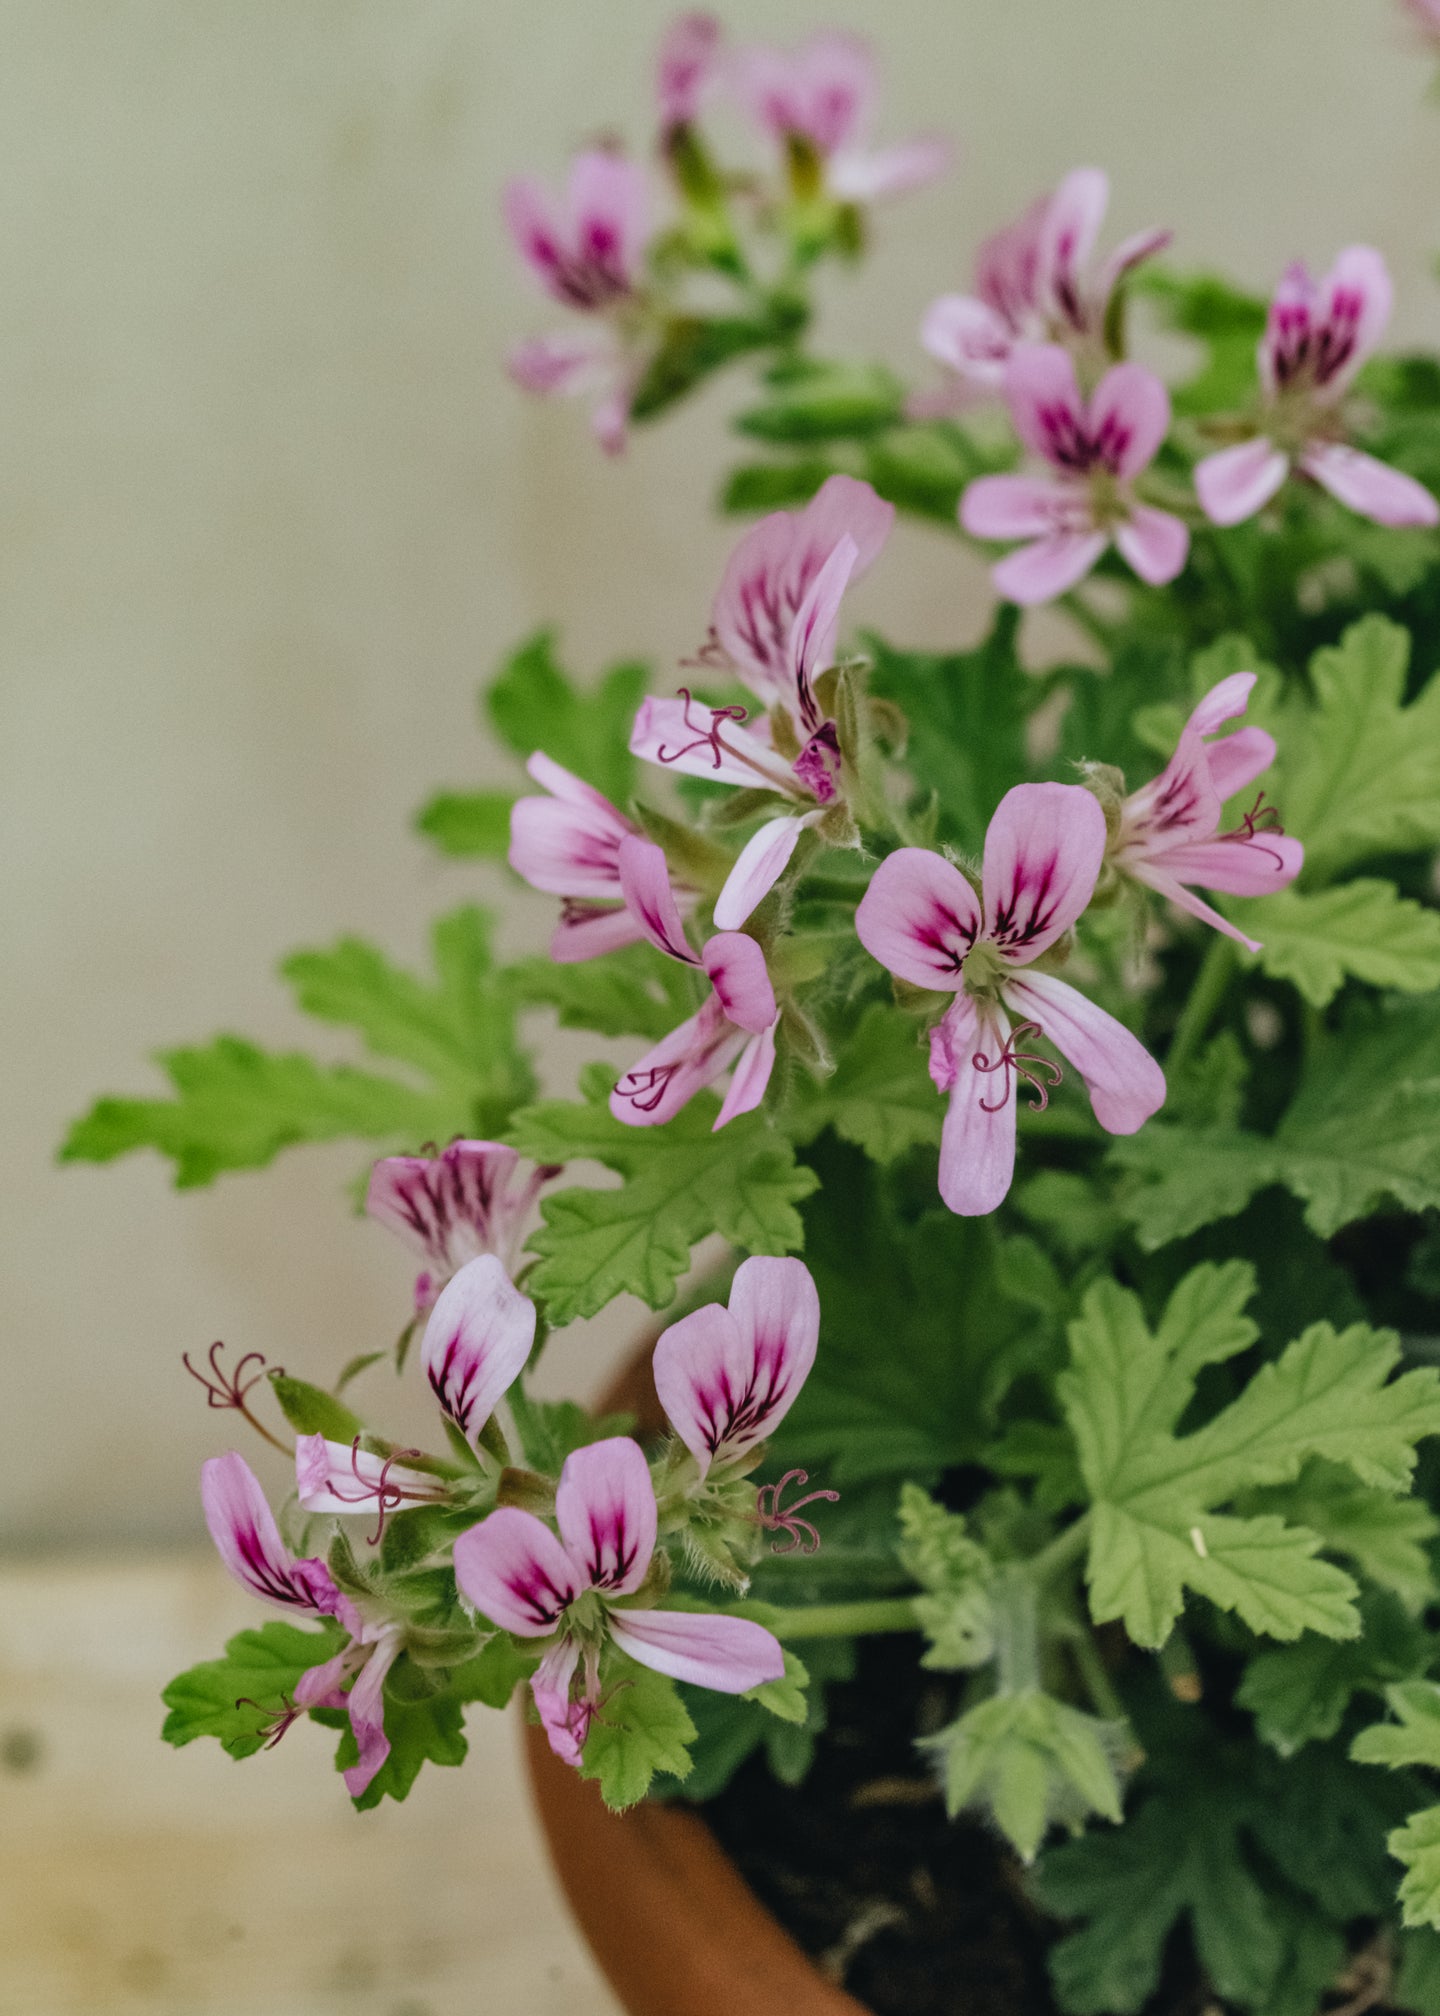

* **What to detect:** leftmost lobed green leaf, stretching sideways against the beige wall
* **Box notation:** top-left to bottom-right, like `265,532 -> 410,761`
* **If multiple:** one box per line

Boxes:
61,1036 -> 443,1189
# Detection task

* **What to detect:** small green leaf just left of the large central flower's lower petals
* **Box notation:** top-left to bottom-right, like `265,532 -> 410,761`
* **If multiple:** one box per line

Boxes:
791,1002 -> 944,1163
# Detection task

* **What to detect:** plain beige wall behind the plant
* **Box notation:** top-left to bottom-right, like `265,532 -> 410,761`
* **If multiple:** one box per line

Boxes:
11,0 -> 1440,1548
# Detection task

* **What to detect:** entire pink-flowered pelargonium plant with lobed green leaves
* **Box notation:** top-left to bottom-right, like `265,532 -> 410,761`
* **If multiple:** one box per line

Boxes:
65,10 -> 1440,2016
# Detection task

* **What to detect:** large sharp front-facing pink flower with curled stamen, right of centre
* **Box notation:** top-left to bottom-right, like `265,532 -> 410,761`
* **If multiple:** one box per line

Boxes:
855,784 -> 1166,1218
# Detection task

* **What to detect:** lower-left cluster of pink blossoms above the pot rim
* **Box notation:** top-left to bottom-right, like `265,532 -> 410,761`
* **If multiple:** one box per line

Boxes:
202,1141 -> 835,1798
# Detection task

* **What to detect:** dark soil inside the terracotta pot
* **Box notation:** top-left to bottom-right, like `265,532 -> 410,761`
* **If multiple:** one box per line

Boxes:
704,1637 -> 1384,2016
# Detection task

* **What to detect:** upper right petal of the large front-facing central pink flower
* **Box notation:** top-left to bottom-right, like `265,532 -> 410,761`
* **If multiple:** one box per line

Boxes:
984,784 -> 1105,966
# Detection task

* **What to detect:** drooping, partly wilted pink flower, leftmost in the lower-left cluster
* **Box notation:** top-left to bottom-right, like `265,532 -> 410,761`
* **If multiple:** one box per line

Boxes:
200,1450 -> 401,1798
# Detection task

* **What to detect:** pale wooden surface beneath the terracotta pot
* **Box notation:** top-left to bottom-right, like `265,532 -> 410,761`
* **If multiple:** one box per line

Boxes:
0,1556 -> 617,2016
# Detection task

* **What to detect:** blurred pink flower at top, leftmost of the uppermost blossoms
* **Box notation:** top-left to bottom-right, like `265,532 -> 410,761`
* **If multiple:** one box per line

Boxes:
504,149 -> 649,454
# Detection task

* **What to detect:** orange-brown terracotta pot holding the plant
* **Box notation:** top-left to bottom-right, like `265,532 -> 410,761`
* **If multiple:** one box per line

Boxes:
524,1349 -> 865,2016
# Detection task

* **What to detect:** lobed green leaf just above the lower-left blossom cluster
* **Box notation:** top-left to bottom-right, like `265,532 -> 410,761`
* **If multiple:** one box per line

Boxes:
508,1093 -> 817,1325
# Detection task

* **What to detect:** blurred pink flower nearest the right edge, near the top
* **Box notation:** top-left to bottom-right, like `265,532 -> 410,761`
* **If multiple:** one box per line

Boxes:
1196,246 -> 1440,526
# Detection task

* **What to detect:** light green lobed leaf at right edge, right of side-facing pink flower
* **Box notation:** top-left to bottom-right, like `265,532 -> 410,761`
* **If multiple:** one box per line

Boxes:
1281,615 -> 1440,885
